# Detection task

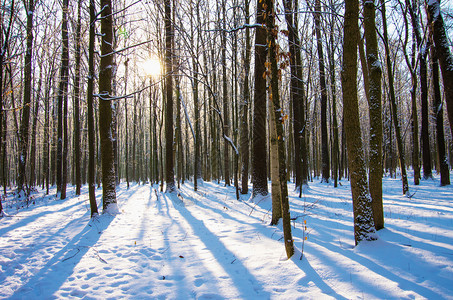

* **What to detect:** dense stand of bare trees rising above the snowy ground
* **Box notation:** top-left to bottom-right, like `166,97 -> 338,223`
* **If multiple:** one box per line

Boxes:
0,0 -> 453,297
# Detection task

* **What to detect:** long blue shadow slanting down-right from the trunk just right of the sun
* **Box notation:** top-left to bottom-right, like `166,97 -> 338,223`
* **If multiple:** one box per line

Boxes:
165,195 -> 270,298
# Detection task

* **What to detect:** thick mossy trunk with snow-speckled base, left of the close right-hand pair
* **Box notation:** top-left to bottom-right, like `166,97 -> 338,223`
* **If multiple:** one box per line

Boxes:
341,0 -> 377,245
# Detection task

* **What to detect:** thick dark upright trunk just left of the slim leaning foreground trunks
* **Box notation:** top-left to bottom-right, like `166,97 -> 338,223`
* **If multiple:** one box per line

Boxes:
252,0 -> 268,198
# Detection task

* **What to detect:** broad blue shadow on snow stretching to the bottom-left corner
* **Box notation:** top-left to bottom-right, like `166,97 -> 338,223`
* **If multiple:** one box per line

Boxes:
10,215 -> 114,299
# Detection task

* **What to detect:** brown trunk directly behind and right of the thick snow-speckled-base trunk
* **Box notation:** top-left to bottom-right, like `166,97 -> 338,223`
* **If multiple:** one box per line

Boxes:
363,0 -> 384,230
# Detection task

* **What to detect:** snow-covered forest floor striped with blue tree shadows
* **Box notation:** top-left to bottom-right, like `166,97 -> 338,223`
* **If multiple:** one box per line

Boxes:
0,173 -> 453,299
